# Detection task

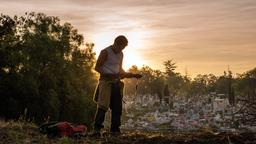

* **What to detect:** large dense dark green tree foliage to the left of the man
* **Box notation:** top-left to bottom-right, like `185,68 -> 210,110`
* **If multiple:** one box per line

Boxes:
0,13 -> 96,122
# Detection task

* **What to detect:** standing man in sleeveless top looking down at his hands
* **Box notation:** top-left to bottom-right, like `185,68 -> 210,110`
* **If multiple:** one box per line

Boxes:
91,35 -> 142,136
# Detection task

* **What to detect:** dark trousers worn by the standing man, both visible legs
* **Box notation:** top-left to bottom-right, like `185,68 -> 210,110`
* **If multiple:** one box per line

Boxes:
94,82 -> 122,132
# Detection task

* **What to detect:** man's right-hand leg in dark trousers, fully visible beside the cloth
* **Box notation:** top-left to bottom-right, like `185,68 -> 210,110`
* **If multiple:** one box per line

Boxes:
110,83 -> 122,132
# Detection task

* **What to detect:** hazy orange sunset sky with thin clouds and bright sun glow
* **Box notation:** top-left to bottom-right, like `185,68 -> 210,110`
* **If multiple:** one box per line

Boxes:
0,0 -> 256,77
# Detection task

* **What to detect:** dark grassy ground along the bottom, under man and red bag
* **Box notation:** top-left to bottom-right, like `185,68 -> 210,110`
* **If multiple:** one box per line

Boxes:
0,121 -> 256,144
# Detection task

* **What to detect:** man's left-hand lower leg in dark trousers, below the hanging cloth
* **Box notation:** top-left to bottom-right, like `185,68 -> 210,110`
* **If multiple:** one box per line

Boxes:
94,107 -> 106,132
